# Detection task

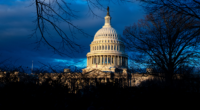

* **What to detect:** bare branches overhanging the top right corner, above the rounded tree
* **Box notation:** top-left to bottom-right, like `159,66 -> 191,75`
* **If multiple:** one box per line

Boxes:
139,0 -> 200,28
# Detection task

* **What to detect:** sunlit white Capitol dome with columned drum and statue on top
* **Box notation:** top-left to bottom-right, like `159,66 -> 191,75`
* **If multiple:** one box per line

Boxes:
82,7 -> 128,72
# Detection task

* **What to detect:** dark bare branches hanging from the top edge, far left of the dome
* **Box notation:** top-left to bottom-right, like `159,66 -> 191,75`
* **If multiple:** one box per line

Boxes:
29,0 -> 89,57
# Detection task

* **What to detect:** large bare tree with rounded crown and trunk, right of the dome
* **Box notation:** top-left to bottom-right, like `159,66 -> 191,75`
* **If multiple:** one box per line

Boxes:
123,10 -> 200,84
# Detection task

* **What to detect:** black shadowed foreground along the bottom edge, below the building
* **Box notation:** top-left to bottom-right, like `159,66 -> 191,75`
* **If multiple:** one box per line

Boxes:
0,74 -> 200,110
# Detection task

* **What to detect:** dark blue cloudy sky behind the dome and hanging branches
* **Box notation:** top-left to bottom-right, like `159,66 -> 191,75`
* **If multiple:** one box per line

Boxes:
0,0 -> 145,73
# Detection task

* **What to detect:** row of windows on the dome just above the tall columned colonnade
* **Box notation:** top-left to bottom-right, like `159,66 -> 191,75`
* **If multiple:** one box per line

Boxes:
92,45 -> 124,51
